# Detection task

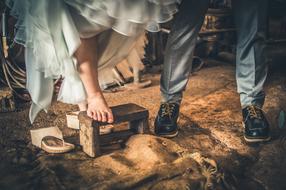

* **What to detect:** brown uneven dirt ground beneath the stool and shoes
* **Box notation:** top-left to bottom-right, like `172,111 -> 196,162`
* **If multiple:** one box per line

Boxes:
0,62 -> 286,190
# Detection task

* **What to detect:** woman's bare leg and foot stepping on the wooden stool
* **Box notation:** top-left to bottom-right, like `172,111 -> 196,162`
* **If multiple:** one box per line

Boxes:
75,37 -> 113,123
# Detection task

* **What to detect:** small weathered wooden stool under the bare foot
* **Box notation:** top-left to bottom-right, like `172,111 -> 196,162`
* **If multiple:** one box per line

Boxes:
79,104 -> 149,157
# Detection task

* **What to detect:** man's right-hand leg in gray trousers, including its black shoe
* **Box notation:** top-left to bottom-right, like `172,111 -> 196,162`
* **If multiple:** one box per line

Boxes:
233,0 -> 270,142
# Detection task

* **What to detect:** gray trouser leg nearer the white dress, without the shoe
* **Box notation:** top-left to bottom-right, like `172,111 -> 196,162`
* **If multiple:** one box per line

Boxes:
161,0 -> 209,103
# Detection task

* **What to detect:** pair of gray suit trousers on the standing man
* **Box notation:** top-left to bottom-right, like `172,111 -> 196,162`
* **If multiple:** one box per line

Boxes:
161,0 -> 268,107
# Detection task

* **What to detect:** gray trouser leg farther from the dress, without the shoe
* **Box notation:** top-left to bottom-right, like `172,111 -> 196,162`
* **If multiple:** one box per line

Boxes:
233,0 -> 267,108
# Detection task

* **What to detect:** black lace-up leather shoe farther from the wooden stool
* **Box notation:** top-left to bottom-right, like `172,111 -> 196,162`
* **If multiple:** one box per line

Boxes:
242,105 -> 271,142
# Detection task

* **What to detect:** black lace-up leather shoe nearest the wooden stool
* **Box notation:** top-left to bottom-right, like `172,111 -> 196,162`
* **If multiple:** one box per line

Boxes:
154,103 -> 180,138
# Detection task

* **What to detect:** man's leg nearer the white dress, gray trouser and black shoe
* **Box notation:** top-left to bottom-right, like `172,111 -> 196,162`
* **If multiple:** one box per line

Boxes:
155,0 -> 209,137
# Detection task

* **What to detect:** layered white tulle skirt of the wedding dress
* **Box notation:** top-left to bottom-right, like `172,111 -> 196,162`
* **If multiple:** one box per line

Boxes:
6,0 -> 180,121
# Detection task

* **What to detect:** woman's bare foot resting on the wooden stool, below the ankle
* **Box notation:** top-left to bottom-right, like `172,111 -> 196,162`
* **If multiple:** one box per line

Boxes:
87,93 -> 114,123
